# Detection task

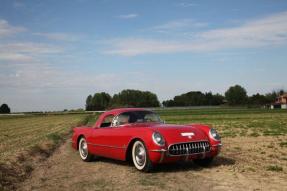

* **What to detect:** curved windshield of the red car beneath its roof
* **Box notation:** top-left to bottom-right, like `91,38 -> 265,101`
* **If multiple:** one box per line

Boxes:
112,111 -> 161,126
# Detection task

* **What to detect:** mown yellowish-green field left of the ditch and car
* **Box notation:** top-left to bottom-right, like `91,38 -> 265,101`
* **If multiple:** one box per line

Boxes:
0,114 -> 89,162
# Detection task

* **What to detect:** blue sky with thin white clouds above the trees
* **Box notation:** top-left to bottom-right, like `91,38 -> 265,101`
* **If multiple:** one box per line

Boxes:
0,0 -> 287,111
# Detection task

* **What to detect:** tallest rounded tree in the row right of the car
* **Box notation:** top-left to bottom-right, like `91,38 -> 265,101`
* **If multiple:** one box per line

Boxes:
225,85 -> 248,105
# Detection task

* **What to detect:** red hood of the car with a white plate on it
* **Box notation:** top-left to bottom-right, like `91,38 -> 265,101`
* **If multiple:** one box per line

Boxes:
132,124 -> 209,144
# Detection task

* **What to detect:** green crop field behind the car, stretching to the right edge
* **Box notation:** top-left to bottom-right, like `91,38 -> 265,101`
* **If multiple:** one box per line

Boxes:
157,108 -> 287,137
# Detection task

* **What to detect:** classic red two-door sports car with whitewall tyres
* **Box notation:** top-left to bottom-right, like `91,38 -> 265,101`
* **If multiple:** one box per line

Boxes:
72,108 -> 221,171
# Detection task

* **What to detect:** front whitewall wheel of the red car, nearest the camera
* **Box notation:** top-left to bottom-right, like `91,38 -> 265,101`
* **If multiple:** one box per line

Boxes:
132,141 -> 153,172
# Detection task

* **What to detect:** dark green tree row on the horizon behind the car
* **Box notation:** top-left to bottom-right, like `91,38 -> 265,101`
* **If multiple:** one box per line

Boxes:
86,85 -> 284,111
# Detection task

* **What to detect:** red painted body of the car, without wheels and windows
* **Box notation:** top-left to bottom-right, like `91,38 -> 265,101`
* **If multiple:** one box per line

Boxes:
72,108 -> 221,169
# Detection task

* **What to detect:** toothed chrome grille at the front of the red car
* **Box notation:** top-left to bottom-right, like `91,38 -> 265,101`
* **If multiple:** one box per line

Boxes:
168,141 -> 210,155
